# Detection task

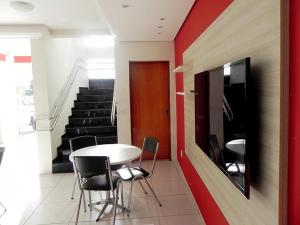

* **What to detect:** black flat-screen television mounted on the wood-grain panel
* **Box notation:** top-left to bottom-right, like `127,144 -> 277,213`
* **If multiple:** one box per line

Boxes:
194,58 -> 251,199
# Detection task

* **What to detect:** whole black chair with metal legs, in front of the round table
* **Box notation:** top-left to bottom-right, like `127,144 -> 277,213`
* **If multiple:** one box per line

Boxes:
73,156 -> 124,225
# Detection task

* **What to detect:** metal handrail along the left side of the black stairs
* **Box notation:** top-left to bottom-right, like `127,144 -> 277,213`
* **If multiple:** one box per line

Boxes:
33,58 -> 85,131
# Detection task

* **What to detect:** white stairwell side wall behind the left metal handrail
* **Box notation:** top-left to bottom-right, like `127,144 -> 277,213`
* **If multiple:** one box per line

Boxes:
46,38 -> 88,159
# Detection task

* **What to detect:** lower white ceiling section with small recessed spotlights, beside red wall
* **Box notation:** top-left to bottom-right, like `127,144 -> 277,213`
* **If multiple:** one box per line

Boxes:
97,0 -> 195,41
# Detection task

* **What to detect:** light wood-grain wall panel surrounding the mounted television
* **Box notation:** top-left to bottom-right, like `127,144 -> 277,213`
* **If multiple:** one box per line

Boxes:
183,0 -> 281,225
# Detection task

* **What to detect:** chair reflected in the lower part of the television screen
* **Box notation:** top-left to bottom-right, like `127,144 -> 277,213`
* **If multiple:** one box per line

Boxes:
209,134 -> 245,175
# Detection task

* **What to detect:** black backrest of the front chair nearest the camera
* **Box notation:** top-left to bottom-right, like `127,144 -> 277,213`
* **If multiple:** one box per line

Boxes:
73,156 -> 113,190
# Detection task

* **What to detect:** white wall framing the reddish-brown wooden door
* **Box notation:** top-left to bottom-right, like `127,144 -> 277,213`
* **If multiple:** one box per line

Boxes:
115,41 -> 176,159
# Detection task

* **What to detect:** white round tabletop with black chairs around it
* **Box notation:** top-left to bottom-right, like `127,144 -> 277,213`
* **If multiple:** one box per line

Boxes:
69,144 -> 142,165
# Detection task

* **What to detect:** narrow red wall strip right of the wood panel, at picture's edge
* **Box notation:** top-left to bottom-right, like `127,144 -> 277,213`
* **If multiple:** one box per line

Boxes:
288,0 -> 300,225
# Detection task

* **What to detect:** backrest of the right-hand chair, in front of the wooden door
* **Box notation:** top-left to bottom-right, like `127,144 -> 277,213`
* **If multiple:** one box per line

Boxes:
139,137 -> 159,174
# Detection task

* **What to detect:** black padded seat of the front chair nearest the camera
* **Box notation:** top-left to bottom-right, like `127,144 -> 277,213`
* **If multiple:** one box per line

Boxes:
82,175 -> 120,191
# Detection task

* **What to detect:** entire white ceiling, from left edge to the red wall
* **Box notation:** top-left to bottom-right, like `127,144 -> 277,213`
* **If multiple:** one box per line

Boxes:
0,0 -> 195,41
